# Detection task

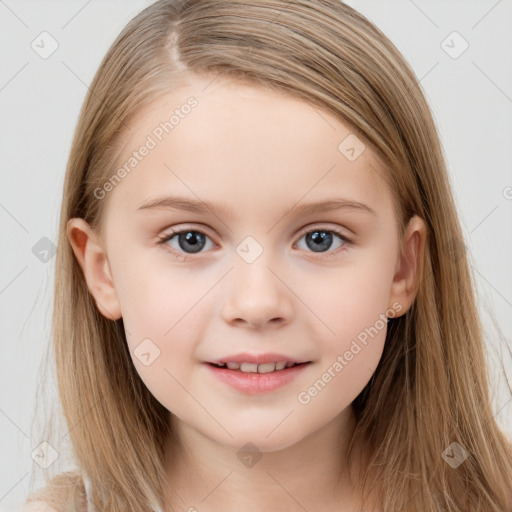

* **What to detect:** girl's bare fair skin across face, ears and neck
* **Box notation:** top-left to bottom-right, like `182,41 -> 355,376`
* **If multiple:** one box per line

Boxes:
68,76 -> 425,512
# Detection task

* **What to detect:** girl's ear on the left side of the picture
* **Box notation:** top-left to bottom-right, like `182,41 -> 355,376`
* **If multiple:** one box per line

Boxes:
67,218 -> 122,320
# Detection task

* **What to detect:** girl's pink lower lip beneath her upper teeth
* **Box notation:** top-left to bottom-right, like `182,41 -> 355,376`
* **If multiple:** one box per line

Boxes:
206,363 -> 310,395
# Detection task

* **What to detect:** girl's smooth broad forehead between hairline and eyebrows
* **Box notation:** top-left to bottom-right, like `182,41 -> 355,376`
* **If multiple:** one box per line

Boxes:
103,76 -> 390,220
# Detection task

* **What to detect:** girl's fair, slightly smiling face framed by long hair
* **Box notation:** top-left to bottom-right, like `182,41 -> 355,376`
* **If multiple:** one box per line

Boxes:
71,73 -> 422,450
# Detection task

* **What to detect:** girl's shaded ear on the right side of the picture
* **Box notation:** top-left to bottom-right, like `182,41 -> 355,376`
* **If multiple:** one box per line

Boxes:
388,215 -> 427,317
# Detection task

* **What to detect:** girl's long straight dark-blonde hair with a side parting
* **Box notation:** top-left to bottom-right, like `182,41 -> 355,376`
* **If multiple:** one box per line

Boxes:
27,0 -> 512,512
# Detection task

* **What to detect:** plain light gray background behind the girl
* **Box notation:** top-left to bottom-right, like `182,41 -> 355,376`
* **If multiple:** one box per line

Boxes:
0,0 -> 512,511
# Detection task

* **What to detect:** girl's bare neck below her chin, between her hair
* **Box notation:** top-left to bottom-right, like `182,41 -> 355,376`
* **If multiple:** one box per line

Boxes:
166,406 -> 376,512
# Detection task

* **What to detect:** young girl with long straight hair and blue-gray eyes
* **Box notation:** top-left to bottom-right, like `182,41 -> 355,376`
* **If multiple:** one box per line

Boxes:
18,0 -> 512,512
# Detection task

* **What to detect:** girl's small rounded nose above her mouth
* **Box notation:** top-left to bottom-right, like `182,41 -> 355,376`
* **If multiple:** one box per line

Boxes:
222,253 -> 293,329
